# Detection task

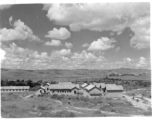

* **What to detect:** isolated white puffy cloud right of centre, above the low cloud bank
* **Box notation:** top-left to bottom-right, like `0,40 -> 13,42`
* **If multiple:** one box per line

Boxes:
88,37 -> 116,51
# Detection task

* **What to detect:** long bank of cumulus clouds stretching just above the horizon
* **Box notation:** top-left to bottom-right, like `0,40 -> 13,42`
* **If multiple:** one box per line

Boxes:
0,43 -> 150,69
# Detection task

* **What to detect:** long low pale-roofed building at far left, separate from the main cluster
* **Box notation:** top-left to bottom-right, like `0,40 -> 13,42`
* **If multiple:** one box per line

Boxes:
0,86 -> 30,92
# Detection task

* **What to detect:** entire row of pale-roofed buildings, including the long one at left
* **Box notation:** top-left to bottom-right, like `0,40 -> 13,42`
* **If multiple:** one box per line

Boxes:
1,82 -> 123,98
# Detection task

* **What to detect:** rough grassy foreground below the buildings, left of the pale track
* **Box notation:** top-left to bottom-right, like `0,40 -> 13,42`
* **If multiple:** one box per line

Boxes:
1,92 -> 152,118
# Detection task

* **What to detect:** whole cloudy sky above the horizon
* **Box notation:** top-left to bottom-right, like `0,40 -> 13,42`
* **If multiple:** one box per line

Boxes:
0,2 -> 150,69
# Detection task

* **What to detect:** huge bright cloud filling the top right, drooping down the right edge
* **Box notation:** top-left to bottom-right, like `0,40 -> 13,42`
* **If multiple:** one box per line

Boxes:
43,2 -> 150,49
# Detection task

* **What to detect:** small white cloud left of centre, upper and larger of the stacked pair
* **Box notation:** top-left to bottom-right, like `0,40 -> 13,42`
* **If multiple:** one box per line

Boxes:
45,27 -> 71,40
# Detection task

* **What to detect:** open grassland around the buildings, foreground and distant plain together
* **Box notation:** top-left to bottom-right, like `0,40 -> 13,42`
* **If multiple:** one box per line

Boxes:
1,68 -> 152,118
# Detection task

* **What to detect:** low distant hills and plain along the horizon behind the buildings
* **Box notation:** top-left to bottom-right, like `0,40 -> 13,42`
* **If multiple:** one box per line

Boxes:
1,68 -> 151,81
